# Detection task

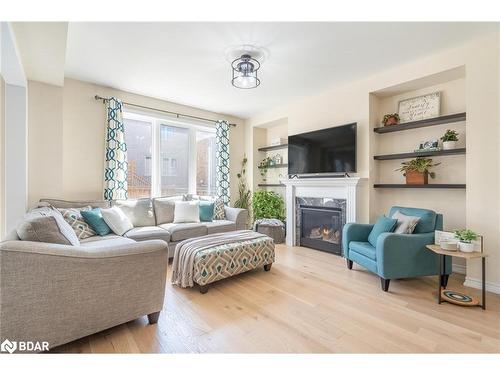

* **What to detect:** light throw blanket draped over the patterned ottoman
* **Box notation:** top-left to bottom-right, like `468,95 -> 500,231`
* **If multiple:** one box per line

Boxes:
172,230 -> 266,288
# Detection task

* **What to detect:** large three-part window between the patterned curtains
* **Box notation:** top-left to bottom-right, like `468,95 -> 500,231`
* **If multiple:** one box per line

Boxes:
124,112 -> 216,198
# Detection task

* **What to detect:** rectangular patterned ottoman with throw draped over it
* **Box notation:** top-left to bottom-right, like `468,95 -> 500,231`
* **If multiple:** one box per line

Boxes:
172,230 -> 274,293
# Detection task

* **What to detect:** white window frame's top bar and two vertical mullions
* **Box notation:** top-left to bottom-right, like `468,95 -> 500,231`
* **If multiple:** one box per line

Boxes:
123,107 -> 215,198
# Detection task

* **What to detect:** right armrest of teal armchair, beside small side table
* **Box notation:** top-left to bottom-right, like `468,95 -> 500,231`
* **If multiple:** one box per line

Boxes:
376,232 -> 451,279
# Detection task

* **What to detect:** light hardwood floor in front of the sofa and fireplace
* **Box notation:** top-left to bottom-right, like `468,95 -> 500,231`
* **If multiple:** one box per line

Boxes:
53,245 -> 500,353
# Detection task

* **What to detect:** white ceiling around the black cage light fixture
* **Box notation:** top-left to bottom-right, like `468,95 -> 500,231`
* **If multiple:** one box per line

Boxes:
40,22 -> 498,118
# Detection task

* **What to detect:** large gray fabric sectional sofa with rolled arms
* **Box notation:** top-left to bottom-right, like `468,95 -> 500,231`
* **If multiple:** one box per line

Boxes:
0,197 -> 247,348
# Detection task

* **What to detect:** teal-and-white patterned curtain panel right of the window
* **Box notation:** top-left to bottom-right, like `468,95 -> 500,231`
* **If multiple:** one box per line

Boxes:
215,121 -> 230,204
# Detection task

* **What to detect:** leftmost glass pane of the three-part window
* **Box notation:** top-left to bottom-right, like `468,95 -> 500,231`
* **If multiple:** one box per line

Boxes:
124,119 -> 153,198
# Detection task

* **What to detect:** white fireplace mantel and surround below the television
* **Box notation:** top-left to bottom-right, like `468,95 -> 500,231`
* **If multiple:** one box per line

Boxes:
281,177 -> 363,246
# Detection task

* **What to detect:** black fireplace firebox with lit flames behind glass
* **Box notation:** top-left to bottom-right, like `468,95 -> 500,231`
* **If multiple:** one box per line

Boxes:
299,205 -> 345,255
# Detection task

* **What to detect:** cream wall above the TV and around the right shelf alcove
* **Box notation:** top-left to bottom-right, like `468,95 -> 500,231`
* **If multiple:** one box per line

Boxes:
247,32 -> 500,292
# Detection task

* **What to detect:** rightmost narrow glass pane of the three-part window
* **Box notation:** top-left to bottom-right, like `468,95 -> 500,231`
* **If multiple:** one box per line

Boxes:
196,131 -> 216,195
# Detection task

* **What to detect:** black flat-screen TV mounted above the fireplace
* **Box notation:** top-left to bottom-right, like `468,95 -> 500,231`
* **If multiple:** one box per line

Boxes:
288,123 -> 356,176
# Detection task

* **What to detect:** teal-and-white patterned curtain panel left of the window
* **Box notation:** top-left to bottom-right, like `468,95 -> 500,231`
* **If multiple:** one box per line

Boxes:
104,97 -> 128,200
